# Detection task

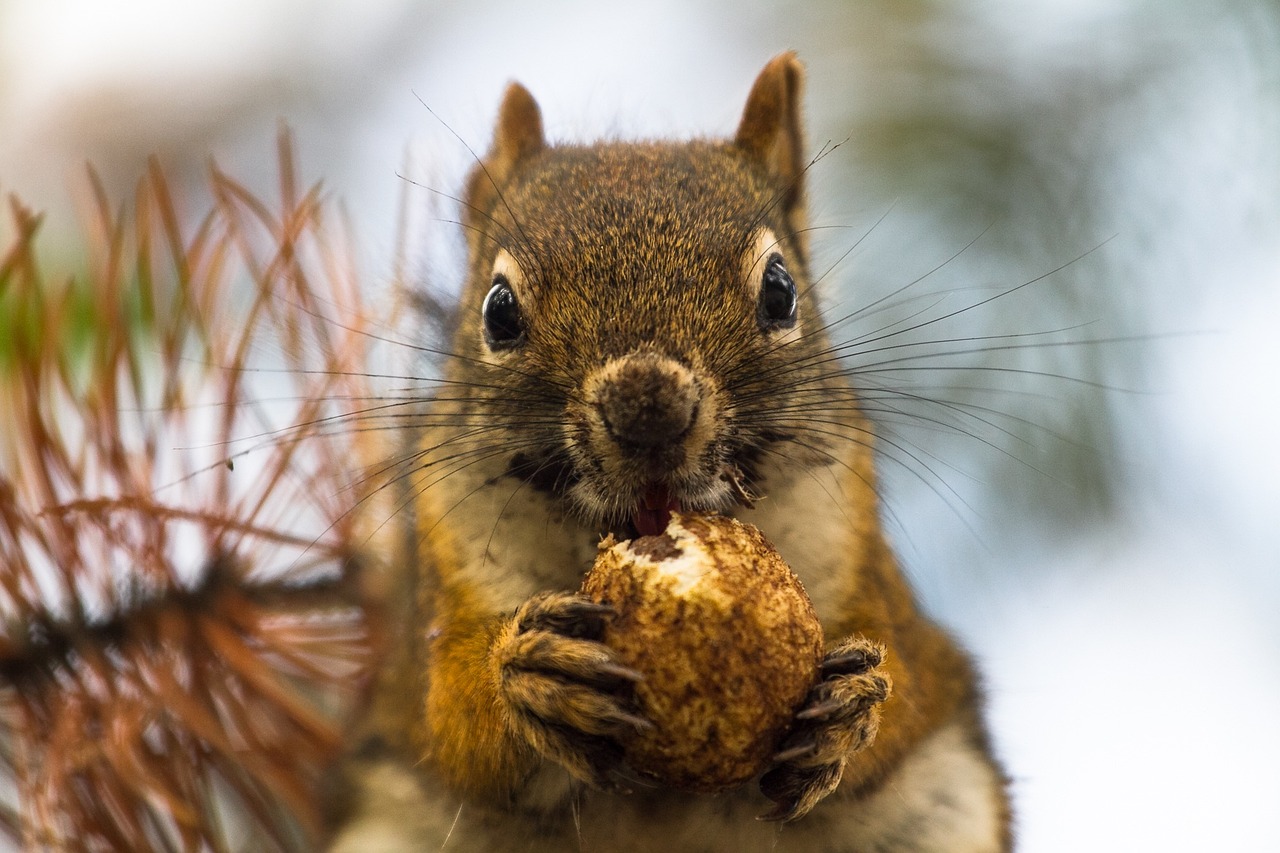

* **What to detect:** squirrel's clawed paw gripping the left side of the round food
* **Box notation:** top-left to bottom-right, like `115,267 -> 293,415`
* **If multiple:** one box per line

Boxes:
493,592 -> 650,790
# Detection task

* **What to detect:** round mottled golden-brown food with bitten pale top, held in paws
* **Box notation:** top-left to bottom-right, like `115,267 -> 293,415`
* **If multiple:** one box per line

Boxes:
582,514 -> 823,792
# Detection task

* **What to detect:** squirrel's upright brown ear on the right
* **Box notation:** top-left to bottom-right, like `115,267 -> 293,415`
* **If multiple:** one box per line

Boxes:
733,50 -> 804,211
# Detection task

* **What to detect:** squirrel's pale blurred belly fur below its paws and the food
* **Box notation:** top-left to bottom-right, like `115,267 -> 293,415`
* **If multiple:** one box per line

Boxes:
333,722 -> 1001,853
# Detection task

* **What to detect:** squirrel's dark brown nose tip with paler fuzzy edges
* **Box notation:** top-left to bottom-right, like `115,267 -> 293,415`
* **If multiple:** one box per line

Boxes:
596,352 -> 701,452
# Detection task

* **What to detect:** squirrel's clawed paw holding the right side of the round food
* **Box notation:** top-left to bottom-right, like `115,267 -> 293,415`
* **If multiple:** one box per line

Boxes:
760,637 -> 891,822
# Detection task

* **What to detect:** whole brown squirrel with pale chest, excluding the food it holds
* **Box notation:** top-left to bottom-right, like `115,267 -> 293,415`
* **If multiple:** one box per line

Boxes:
330,53 -> 1012,853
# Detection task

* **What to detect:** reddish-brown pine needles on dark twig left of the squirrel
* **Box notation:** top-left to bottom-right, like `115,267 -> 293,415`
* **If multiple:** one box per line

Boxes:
0,137 -> 380,850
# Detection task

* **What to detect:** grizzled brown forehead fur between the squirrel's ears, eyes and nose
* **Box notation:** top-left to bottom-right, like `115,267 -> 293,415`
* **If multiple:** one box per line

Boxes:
467,141 -> 808,361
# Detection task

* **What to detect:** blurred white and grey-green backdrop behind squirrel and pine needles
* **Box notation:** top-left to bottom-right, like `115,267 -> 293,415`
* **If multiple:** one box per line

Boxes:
0,0 -> 1280,852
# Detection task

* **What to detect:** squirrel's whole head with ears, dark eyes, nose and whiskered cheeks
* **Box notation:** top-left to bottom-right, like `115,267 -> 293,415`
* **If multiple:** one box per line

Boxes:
456,53 -> 826,533
